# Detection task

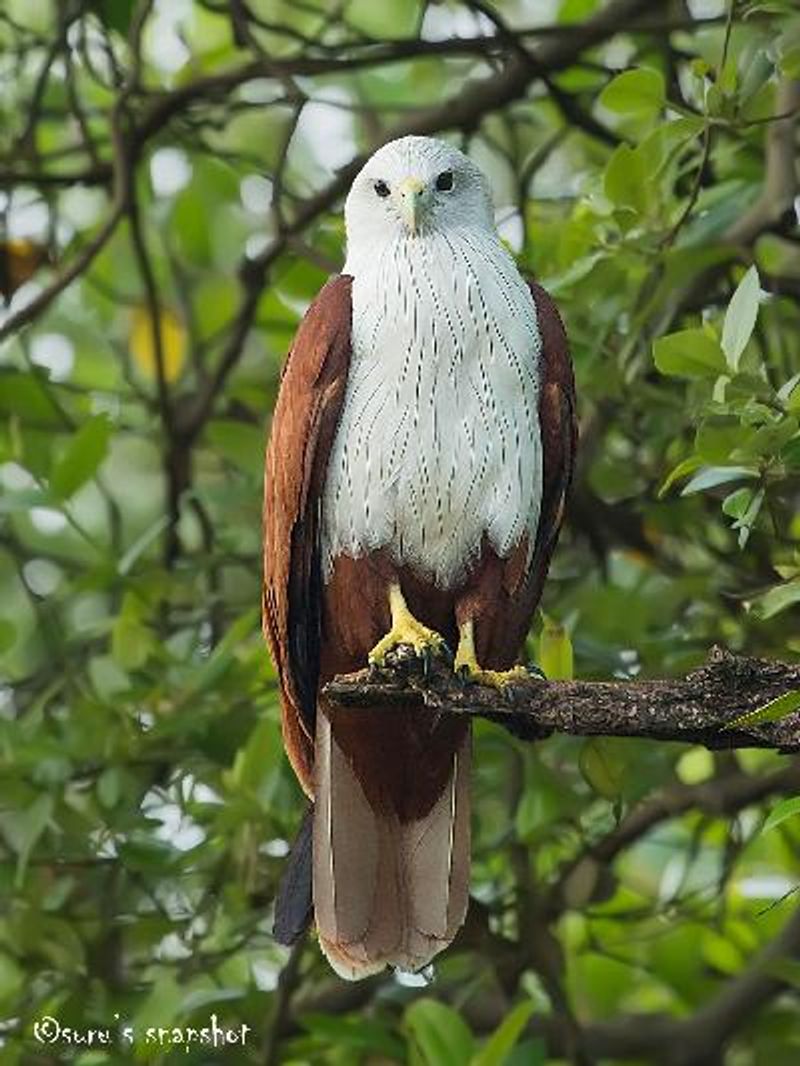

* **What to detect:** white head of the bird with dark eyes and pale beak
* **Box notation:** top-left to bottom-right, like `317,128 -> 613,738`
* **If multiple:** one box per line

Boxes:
345,136 -> 495,273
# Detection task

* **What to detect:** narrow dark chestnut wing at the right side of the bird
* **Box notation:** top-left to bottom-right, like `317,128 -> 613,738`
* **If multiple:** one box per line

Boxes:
529,281 -> 578,602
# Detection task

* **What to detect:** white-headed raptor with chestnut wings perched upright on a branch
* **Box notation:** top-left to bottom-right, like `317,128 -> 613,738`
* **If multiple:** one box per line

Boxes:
262,135 -> 577,981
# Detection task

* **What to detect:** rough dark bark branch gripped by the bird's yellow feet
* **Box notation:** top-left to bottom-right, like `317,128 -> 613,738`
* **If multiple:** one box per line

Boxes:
324,647 -> 800,752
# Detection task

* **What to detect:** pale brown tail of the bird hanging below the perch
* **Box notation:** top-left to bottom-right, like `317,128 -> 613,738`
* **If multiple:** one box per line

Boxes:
314,708 -> 470,981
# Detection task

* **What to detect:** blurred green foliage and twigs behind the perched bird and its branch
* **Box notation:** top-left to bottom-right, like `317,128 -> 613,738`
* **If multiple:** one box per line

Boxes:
0,0 -> 800,1066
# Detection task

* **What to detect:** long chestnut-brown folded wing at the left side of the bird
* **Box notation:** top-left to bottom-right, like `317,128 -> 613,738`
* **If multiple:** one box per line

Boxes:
262,275 -> 352,795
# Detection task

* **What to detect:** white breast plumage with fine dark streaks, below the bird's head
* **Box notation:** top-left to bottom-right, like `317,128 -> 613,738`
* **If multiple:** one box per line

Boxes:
322,230 -> 542,588
